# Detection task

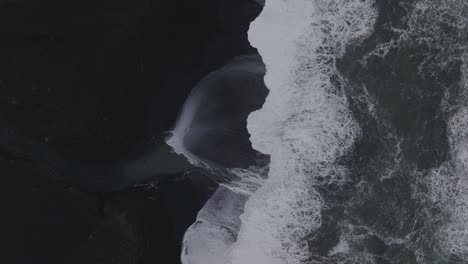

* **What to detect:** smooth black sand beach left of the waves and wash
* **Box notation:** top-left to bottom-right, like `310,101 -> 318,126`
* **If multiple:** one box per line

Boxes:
0,0 -> 261,264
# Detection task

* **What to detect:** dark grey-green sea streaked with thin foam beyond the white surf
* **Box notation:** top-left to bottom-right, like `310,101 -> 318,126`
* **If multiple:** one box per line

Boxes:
311,1 -> 468,263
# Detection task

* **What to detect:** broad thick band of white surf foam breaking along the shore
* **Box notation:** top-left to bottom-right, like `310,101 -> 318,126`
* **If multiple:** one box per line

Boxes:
230,0 -> 376,264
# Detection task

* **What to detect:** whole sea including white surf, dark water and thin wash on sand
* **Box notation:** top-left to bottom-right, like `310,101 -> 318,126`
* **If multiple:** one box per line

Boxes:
168,0 -> 468,264
